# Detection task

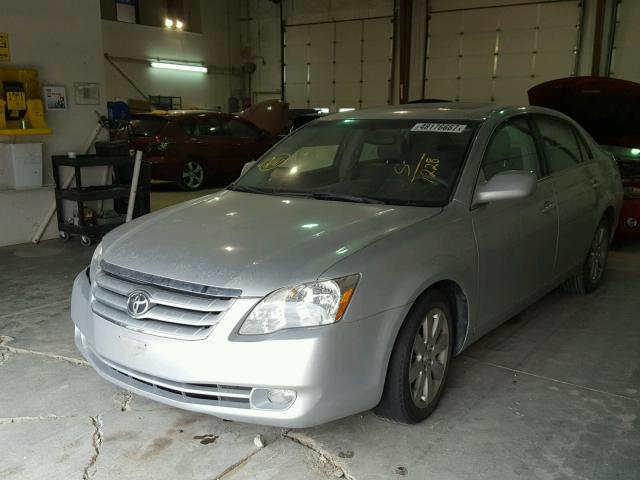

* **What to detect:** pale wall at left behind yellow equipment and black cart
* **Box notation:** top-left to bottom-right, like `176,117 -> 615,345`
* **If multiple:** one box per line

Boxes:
0,0 -> 106,245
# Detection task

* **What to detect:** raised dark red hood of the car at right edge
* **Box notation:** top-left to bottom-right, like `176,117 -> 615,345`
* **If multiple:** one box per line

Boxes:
528,77 -> 640,147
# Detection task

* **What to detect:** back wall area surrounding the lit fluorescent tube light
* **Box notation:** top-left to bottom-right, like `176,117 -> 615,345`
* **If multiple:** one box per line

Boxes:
102,0 -> 243,111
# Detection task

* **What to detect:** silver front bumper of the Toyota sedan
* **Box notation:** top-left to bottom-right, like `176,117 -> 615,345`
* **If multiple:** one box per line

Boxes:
71,272 -> 405,428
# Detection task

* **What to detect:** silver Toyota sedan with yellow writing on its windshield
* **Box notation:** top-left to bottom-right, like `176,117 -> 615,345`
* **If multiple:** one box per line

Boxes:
71,104 -> 622,427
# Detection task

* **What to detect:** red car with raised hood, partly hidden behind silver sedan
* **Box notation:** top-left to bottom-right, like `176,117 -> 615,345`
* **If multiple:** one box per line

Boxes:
528,77 -> 640,236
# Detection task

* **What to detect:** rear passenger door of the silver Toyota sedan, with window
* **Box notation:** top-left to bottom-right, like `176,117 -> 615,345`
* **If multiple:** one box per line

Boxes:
534,115 -> 601,276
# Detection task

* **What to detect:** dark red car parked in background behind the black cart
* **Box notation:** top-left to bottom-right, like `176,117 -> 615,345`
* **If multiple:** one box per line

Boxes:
129,111 -> 277,190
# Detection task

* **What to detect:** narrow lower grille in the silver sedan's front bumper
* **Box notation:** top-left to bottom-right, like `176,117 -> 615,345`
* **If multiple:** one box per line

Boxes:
91,352 -> 251,408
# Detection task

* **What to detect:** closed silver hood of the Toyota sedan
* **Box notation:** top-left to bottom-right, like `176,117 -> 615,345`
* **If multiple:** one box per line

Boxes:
103,191 -> 442,296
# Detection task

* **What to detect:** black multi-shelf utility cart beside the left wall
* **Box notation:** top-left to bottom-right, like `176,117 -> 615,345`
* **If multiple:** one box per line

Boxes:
52,155 -> 150,246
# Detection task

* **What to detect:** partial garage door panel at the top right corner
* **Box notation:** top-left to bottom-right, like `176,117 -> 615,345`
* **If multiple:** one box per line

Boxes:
610,0 -> 640,82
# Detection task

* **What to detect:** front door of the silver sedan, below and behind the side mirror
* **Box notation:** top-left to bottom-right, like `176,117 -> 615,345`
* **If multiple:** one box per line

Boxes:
471,115 -> 558,331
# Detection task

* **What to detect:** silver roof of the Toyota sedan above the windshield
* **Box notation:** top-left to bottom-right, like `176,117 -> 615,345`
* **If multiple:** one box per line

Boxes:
320,102 -> 521,121
